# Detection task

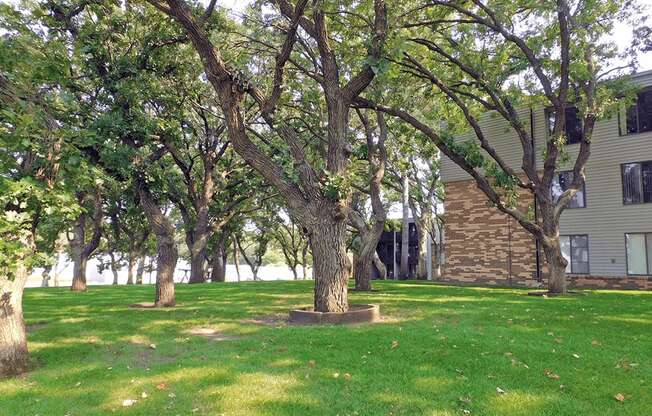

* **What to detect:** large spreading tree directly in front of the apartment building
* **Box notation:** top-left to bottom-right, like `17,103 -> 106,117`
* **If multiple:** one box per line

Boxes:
360,0 -> 629,293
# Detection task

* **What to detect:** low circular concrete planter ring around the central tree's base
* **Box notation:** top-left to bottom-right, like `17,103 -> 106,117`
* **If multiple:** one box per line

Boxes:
289,305 -> 380,325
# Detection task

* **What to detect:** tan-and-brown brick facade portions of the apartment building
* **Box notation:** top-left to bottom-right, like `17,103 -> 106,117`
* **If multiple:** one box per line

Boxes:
440,180 -> 652,290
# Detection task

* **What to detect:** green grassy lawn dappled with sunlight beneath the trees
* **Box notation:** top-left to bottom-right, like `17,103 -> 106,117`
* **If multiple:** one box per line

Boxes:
0,282 -> 652,416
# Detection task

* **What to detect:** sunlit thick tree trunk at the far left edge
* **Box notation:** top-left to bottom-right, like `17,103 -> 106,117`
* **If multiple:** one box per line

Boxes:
0,266 -> 28,378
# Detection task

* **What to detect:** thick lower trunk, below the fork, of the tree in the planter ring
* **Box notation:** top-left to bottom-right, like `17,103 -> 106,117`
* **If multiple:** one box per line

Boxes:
309,215 -> 351,312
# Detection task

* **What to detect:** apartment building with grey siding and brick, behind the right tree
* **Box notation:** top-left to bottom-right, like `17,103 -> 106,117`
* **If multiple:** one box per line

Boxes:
442,71 -> 652,290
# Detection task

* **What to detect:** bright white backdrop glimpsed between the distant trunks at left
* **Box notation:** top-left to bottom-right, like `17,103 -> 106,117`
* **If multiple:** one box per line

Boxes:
27,256 -> 312,287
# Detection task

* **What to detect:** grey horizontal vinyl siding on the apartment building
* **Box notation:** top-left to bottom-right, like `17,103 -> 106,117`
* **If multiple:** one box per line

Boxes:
442,71 -> 652,276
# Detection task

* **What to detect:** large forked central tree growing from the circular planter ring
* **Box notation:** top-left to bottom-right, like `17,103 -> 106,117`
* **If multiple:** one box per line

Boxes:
143,0 -> 387,312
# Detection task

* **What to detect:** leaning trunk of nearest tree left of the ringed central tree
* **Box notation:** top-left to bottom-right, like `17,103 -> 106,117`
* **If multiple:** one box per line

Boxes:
136,177 -> 178,307
